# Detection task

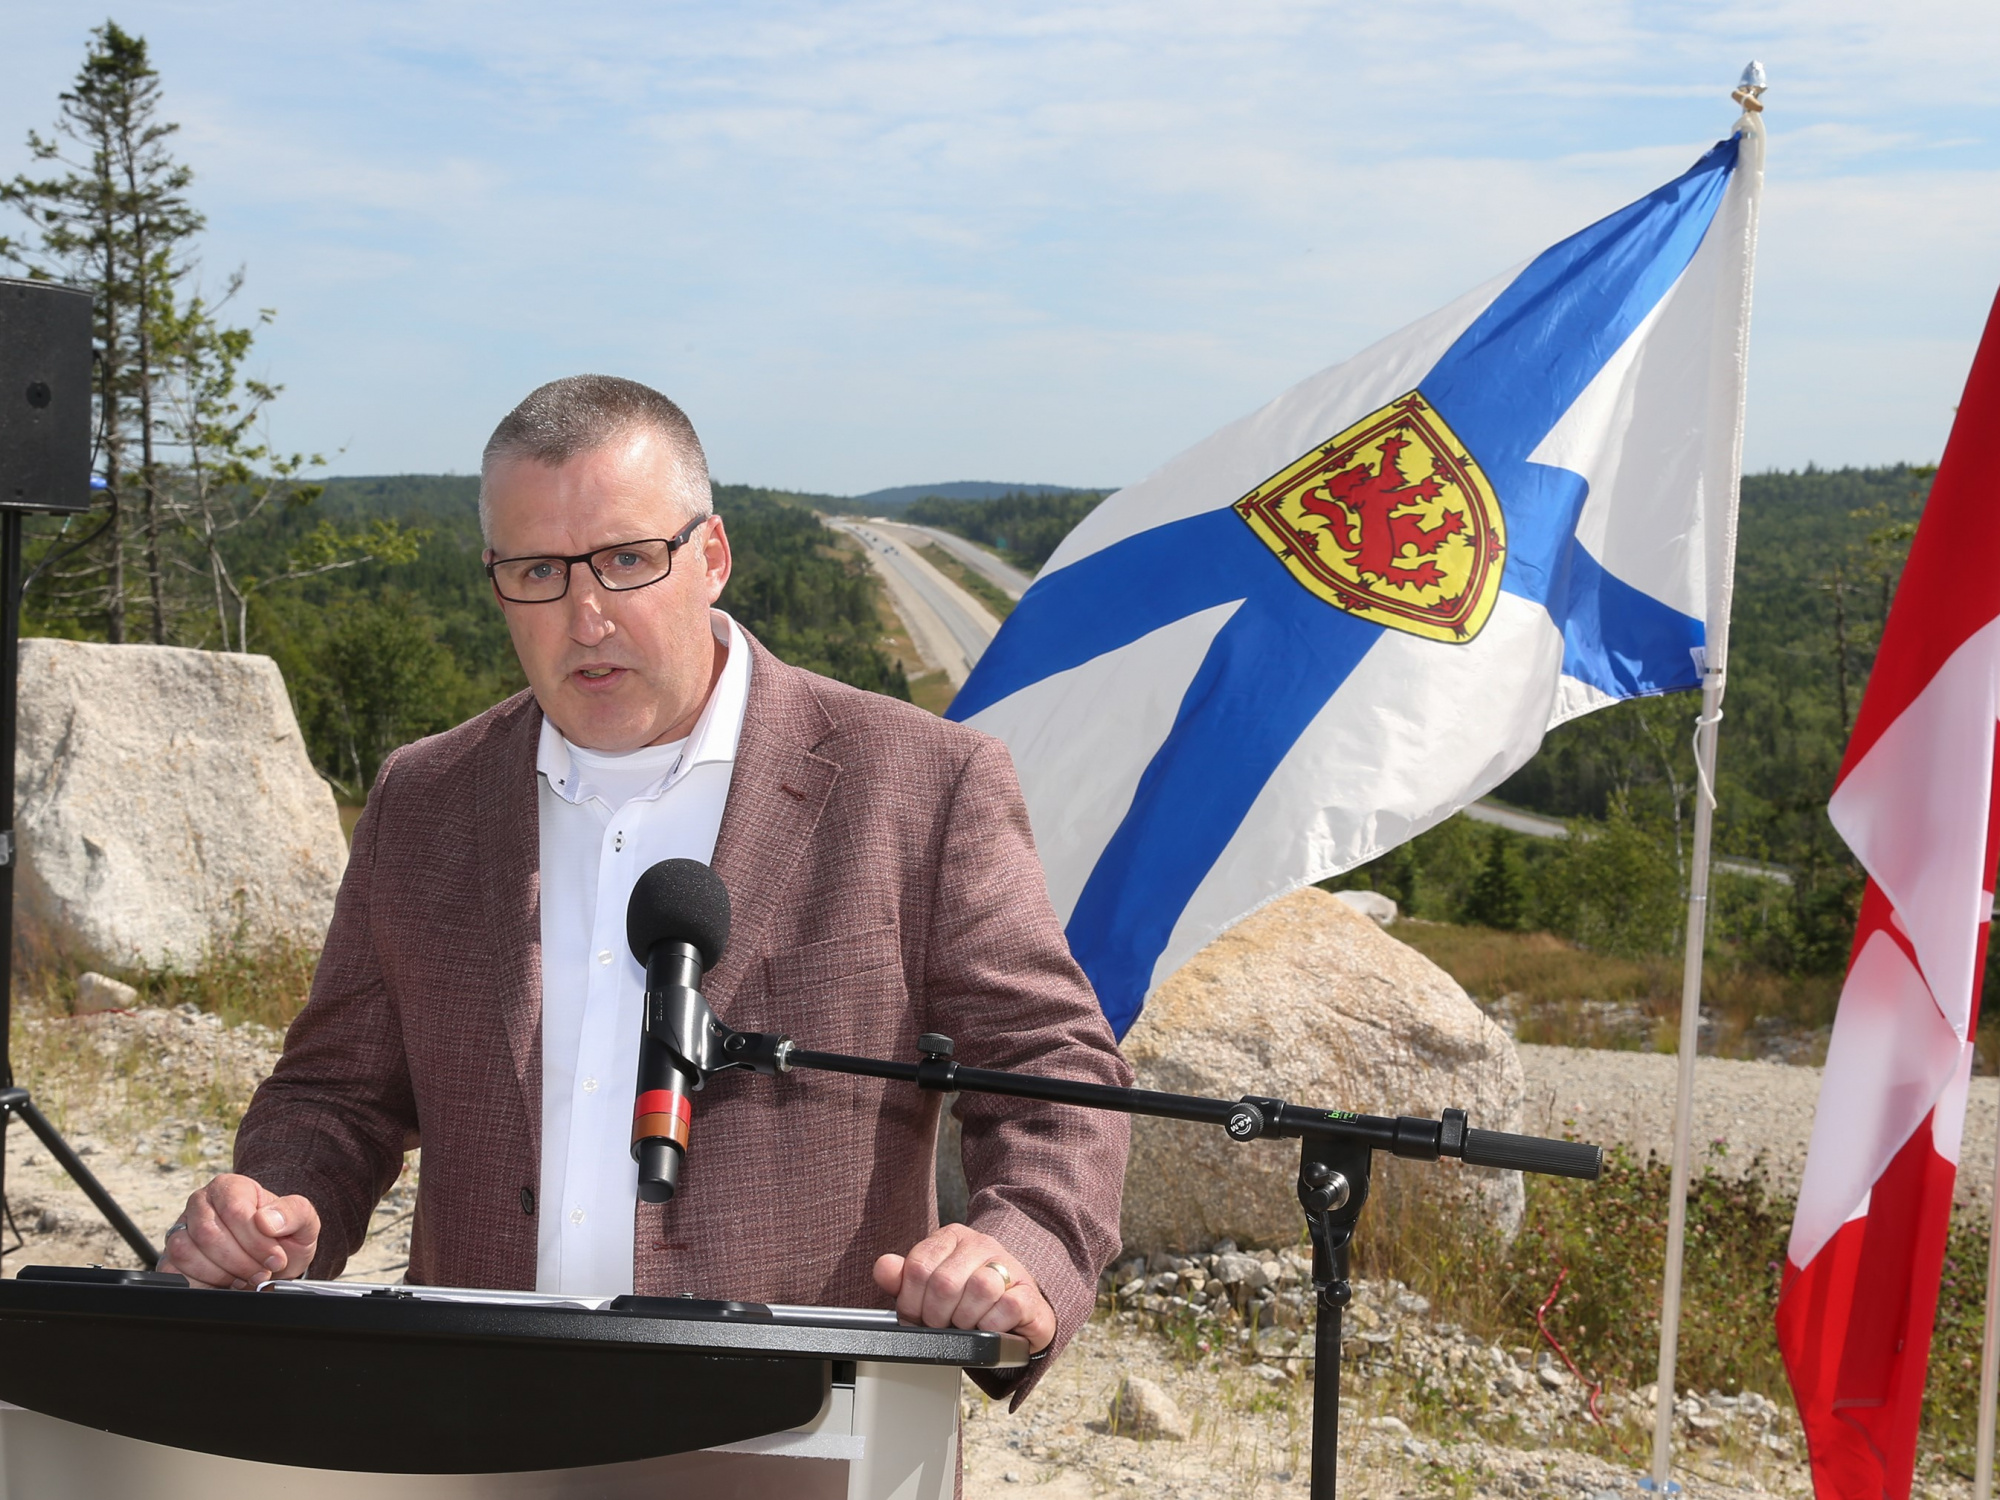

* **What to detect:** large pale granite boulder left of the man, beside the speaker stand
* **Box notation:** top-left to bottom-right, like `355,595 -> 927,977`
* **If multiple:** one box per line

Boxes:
14,640 -> 348,972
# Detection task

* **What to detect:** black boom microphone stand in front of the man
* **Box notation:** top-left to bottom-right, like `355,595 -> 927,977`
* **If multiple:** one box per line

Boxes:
646,986 -> 1604,1500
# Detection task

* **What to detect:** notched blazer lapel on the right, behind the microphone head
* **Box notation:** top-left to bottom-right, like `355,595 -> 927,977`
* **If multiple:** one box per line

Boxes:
704,640 -> 840,1000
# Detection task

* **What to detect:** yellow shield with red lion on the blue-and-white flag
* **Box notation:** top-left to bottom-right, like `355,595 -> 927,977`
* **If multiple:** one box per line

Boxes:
1236,390 -> 1506,642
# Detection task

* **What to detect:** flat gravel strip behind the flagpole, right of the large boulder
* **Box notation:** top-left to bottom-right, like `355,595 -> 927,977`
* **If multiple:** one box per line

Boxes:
1520,1046 -> 2000,1208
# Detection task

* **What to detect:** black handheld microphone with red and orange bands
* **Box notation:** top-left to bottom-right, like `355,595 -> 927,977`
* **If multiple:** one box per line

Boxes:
626,860 -> 730,1204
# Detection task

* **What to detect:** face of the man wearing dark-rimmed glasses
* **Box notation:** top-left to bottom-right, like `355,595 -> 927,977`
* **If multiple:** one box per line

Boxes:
484,432 -> 730,752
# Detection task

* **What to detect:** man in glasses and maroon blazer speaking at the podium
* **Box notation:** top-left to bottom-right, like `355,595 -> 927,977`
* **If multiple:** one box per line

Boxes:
160,376 -> 1130,1394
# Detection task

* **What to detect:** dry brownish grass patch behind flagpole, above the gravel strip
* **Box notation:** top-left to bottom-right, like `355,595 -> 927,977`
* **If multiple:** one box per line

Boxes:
1392,920 -> 1840,1066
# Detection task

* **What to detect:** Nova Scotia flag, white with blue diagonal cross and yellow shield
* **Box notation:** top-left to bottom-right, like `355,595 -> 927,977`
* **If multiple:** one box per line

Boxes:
950,118 -> 1762,1036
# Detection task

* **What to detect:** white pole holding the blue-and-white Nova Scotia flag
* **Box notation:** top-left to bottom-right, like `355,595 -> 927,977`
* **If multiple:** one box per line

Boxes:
1648,62 -> 1764,1494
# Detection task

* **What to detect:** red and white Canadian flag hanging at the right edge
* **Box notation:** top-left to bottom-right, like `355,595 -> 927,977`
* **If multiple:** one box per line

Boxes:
1778,284 -> 2000,1500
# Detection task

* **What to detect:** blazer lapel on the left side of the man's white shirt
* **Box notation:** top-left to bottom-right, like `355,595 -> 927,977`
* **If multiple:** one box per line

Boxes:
480,694 -> 542,1120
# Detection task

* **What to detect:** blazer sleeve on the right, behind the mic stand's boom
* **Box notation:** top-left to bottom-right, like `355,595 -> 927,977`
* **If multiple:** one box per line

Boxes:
924,738 -> 1132,1406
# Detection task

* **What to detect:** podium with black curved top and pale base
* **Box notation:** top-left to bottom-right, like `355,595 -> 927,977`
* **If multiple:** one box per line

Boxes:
0,1268 -> 1028,1500
